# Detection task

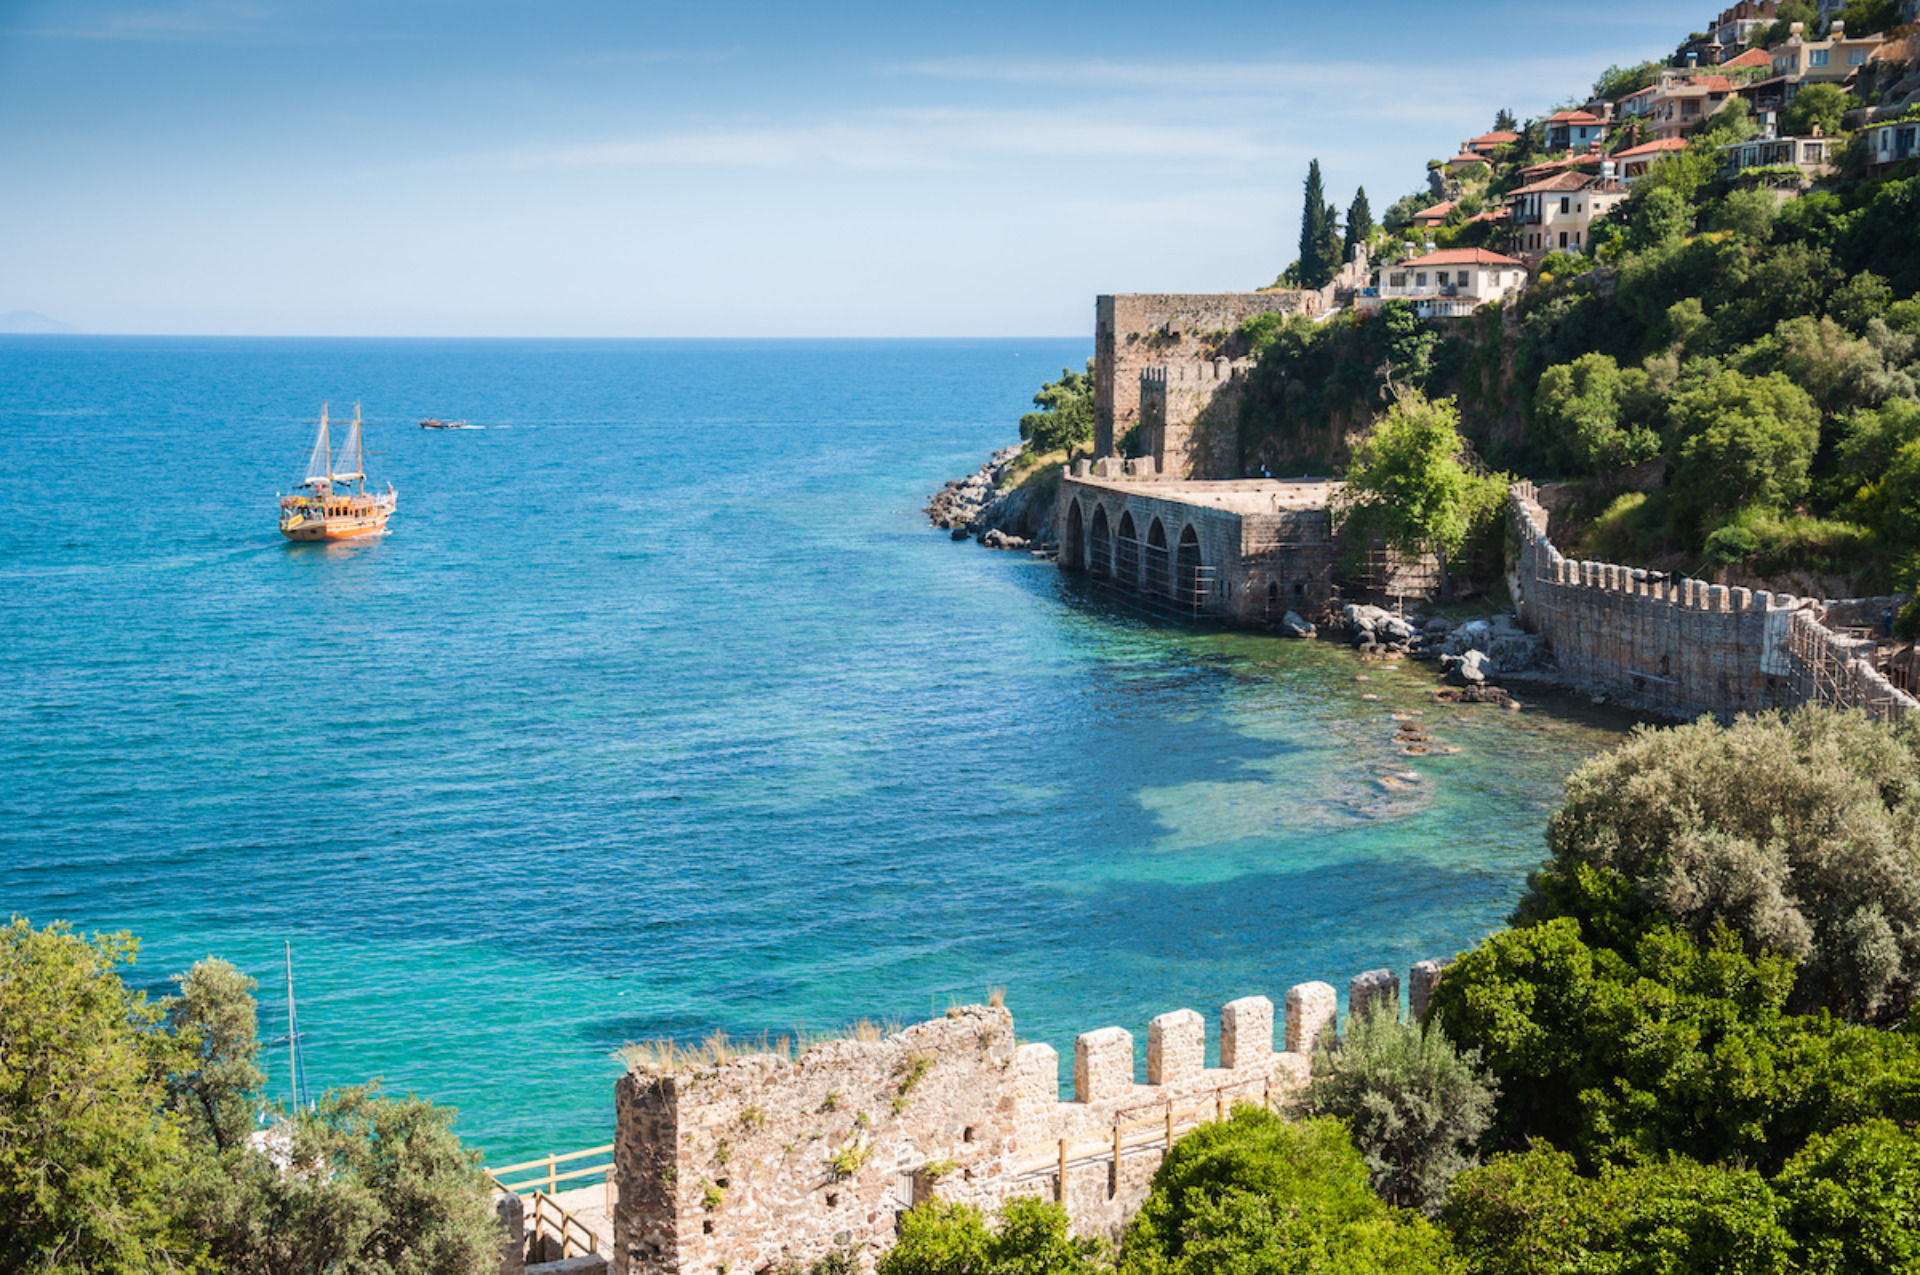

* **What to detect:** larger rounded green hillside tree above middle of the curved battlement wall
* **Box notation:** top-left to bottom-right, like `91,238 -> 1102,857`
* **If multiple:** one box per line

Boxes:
1668,371 -> 1820,518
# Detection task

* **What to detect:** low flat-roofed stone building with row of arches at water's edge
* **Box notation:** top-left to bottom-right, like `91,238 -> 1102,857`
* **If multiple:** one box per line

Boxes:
1054,468 -> 1338,624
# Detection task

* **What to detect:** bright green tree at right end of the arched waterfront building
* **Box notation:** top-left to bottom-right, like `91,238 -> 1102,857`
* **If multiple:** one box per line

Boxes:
1334,390 -> 1505,591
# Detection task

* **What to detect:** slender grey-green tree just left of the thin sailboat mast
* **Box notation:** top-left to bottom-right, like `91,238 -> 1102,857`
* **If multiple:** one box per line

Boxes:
167,956 -> 267,1150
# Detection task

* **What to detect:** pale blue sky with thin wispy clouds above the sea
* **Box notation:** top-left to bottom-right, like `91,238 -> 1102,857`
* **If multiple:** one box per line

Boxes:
0,0 -> 1681,336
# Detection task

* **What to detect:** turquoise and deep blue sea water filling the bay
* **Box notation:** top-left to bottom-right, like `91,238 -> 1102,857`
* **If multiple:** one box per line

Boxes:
0,338 -> 1620,1162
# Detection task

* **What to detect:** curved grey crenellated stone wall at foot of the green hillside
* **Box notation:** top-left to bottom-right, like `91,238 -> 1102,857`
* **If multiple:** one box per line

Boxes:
1507,482 -> 1920,718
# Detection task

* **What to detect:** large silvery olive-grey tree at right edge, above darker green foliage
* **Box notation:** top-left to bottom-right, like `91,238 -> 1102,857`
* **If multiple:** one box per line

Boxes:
1521,709 -> 1920,1022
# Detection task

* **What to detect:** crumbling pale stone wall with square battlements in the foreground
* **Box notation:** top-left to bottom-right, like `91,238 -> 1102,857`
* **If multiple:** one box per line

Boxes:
612,960 -> 1442,1275
